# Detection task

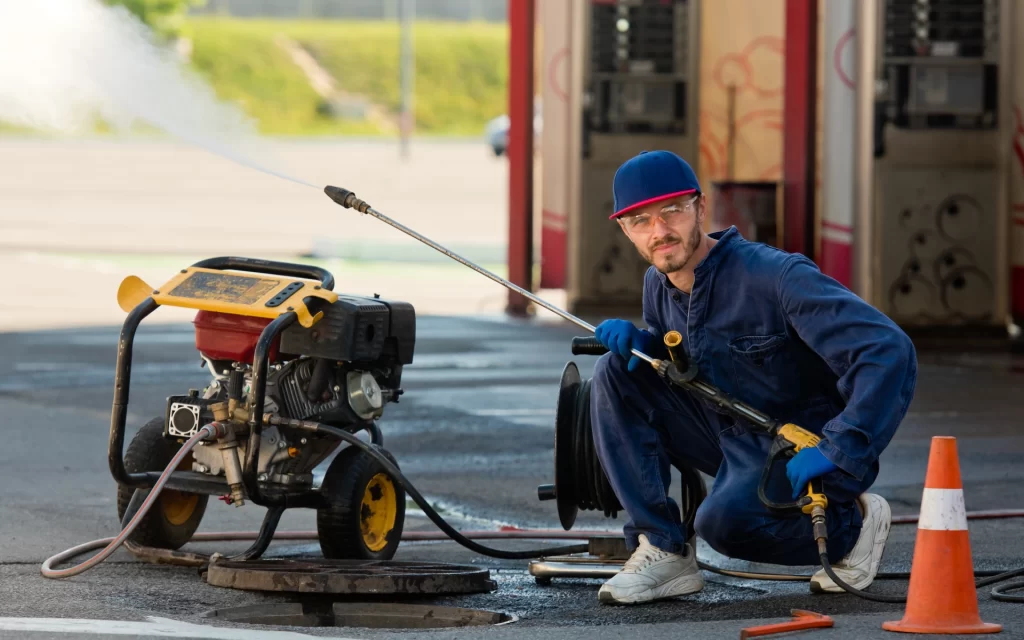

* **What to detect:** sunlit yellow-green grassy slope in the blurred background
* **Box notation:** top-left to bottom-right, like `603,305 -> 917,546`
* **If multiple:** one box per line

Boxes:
188,17 -> 508,135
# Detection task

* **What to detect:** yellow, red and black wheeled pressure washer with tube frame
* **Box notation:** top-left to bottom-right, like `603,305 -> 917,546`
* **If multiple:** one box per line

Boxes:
109,257 -> 416,560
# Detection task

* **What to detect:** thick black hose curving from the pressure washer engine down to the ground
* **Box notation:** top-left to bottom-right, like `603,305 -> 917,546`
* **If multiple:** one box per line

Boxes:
282,418 -> 590,560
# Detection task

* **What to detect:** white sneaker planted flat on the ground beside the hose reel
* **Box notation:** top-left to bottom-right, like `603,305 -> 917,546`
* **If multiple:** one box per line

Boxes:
597,534 -> 703,604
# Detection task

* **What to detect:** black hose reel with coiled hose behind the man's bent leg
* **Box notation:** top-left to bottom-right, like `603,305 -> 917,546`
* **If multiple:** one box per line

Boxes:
537,337 -> 708,539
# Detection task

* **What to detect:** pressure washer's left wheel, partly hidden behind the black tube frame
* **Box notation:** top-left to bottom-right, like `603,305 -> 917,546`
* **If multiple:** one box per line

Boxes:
118,418 -> 210,549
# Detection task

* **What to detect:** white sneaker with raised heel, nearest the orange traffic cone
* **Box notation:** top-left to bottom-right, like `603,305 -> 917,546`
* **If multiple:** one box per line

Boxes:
811,494 -> 893,593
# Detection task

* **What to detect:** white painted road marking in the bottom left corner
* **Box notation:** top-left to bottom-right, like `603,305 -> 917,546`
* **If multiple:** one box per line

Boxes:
0,616 -> 360,640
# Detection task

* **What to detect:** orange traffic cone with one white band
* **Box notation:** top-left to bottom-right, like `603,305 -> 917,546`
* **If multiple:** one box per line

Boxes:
882,436 -> 1002,634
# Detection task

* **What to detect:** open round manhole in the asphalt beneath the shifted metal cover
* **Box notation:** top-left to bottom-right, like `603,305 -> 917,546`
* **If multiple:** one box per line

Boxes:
207,602 -> 515,629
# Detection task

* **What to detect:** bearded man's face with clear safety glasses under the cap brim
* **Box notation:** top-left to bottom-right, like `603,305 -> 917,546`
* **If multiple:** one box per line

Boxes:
618,195 -> 707,273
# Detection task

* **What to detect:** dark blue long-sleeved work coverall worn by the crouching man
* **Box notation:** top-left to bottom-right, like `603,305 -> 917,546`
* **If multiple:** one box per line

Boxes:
591,227 -> 918,566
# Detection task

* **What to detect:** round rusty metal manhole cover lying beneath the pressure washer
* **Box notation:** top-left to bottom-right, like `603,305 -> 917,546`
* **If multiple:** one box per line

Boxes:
206,558 -> 497,595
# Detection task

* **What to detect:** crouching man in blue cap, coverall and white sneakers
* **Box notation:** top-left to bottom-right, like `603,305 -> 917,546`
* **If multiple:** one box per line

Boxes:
591,151 -> 918,604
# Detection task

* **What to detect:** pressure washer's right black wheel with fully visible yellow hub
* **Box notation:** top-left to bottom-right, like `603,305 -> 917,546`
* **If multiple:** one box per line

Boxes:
316,446 -> 406,560
